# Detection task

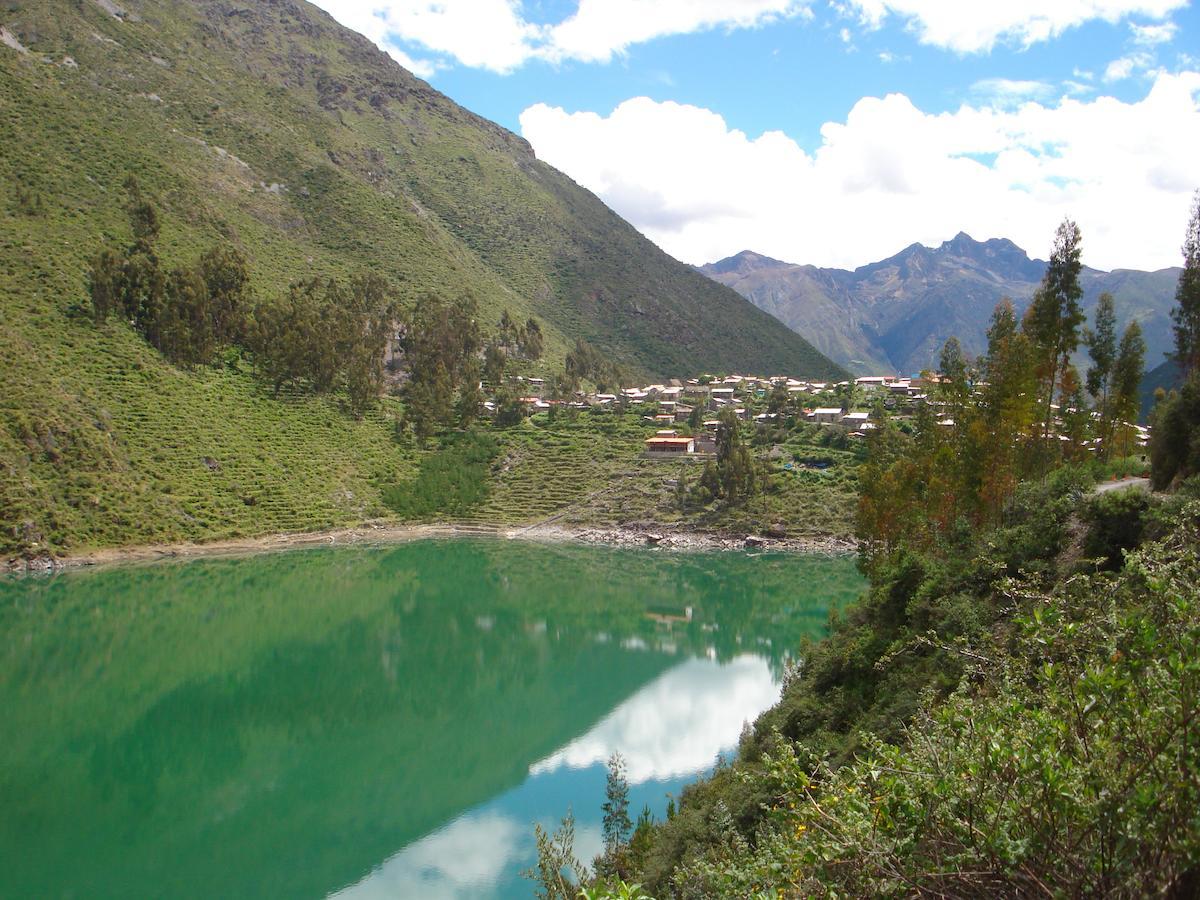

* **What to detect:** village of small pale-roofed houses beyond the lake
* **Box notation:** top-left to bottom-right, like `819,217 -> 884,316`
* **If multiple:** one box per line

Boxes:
484,372 -> 1150,460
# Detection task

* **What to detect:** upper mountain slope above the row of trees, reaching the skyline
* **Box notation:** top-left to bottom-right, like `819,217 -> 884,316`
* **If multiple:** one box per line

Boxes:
0,0 -> 844,374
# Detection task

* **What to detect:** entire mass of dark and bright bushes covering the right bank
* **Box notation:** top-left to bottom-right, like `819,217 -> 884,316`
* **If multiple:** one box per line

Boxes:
588,469 -> 1200,900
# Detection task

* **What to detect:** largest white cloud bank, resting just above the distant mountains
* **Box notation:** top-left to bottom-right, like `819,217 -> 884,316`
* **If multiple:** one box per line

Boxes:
521,72 -> 1200,269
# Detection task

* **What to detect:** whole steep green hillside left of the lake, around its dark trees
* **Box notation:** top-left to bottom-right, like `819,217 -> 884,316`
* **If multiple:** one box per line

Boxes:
0,0 -> 840,551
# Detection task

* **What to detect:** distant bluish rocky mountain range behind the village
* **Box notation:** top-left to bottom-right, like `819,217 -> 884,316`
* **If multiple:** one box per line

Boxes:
700,233 -> 1180,373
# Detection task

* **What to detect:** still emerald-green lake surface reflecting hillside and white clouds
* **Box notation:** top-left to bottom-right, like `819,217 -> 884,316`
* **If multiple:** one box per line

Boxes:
0,540 -> 862,898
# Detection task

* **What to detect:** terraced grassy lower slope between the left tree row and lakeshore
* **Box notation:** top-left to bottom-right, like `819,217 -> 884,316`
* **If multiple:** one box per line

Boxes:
0,314 -> 415,553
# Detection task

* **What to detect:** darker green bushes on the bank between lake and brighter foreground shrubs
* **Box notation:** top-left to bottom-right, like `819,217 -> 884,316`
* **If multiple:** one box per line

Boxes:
636,468 -> 1123,896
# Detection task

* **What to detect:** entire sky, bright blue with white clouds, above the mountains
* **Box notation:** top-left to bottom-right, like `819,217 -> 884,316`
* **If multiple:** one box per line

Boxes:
318,0 -> 1200,269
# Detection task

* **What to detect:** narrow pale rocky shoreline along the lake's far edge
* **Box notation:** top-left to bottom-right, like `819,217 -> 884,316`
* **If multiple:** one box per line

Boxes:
0,521 -> 857,574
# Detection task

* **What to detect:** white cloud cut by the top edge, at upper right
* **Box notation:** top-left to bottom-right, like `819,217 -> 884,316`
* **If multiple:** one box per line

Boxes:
839,0 -> 1187,53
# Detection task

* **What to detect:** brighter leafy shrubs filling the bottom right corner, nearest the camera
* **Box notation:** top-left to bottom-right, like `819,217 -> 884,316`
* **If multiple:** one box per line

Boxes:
673,503 -> 1200,896
